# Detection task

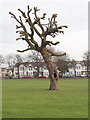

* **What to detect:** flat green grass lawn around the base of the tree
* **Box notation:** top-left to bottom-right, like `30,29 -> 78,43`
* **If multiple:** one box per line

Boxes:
2,79 -> 88,118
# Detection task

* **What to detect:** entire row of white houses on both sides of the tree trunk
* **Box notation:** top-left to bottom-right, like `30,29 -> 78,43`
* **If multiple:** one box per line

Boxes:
0,61 -> 87,78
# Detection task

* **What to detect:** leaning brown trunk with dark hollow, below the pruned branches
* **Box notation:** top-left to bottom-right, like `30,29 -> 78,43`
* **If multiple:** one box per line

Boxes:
41,48 -> 58,90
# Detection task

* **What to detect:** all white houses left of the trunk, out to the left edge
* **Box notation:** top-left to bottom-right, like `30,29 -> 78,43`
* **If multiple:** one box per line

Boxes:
0,62 -> 49,78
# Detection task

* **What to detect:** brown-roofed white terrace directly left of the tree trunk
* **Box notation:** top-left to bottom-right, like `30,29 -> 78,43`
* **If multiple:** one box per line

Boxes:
14,62 -> 49,78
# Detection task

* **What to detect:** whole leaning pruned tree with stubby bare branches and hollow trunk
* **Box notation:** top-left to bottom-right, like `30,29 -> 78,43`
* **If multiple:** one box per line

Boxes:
9,6 -> 67,90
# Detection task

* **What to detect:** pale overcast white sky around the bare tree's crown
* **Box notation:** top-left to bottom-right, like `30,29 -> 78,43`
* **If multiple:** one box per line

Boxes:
0,0 -> 88,60
